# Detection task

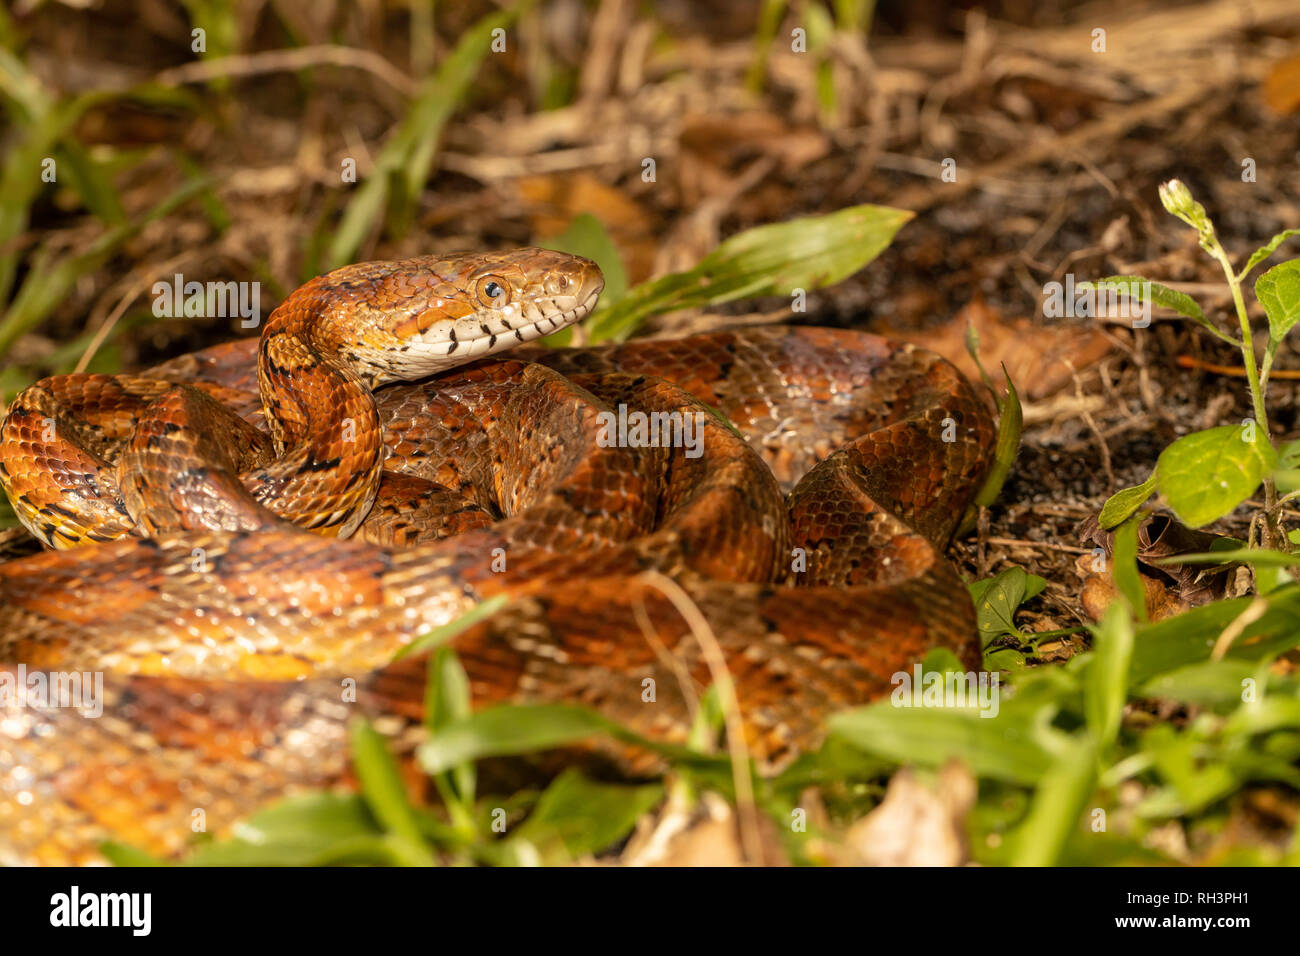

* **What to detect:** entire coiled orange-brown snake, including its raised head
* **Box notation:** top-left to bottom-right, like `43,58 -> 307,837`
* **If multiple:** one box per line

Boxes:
0,248 -> 993,862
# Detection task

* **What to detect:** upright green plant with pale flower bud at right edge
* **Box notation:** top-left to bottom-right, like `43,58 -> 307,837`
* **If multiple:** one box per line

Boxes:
1093,179 -> 1300,551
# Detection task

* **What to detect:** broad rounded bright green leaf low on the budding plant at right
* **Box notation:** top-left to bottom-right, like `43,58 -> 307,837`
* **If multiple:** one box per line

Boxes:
1156,425 -> 1278,528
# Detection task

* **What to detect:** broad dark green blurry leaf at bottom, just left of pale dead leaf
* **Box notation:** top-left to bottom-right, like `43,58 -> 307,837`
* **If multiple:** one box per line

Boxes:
511,769 -> 664,862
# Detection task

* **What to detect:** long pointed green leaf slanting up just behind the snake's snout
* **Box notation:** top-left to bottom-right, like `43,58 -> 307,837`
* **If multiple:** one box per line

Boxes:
589,206 -> 913,342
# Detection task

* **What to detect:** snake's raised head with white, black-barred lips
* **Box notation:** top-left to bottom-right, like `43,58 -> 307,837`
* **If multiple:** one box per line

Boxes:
301,247 -> 605,386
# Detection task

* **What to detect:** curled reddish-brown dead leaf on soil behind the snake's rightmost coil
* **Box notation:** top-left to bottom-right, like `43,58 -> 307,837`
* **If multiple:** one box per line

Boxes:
880,302 -> 1113,402
